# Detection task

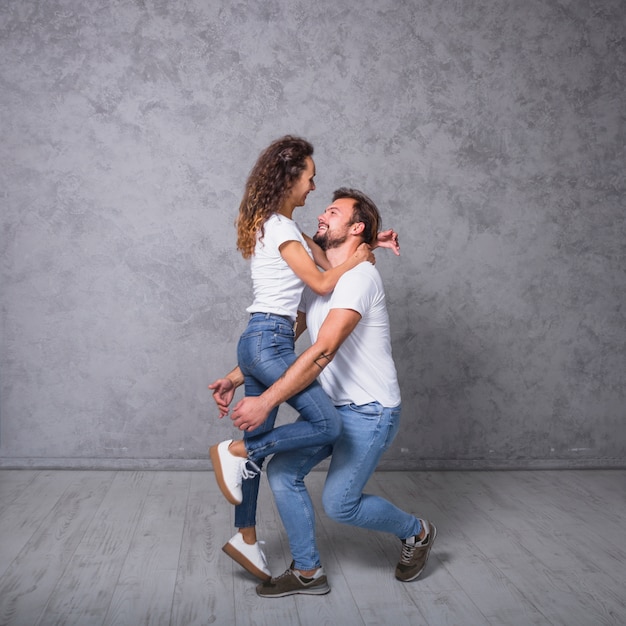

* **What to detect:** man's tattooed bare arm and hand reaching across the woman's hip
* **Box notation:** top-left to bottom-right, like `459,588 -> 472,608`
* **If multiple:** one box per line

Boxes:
231,309 -> 361,430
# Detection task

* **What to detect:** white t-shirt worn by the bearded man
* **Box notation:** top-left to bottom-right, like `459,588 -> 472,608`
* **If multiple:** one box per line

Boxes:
299,262 -> 400,408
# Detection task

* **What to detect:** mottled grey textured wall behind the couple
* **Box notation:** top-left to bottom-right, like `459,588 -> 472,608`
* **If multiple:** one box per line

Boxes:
0,0 -> 626,468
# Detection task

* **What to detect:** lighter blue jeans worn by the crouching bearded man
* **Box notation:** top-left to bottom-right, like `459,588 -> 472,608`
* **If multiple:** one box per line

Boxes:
267,402 -> 421,570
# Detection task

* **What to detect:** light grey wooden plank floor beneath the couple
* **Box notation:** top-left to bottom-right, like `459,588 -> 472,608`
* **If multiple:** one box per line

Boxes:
0,470 -> 626,626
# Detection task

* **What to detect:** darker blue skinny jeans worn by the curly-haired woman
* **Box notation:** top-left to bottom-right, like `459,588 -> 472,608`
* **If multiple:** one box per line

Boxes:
235,313 -> 341,528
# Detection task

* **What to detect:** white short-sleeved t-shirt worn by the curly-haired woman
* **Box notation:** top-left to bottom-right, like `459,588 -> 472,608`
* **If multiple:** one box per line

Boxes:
246,213 -> 313,320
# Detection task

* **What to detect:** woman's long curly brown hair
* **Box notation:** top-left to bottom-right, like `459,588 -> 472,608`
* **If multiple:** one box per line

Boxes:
236,135 -> 313,259
